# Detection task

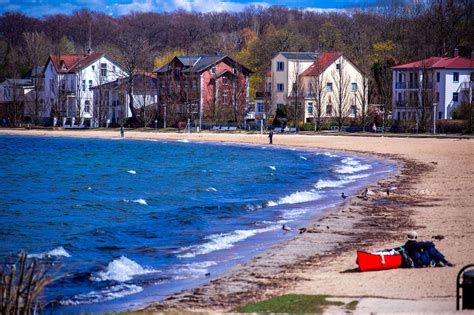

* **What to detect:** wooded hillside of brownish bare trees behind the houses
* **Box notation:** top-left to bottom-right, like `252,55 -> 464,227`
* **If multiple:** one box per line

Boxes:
0,0 -> 474,101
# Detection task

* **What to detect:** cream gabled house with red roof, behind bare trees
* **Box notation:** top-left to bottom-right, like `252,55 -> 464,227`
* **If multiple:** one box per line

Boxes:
299,52 -> 368,122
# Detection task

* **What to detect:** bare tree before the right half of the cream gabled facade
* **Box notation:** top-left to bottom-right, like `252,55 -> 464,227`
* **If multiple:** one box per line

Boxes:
332,58 -> 351,131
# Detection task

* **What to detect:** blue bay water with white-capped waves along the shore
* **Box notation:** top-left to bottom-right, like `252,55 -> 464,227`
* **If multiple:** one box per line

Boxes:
0,136 -> 395,313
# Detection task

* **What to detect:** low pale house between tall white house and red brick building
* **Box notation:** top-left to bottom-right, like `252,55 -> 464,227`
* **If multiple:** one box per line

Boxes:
92,74 -> 158,125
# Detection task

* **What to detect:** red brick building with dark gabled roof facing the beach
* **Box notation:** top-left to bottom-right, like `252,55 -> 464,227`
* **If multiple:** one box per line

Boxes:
153,56 -> 251,128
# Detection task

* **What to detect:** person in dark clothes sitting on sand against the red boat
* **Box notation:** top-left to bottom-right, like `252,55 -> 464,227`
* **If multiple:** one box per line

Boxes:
403,231 -> 454,268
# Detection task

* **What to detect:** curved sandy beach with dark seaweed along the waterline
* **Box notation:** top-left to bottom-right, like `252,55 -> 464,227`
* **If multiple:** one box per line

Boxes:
0,129 -> 474,312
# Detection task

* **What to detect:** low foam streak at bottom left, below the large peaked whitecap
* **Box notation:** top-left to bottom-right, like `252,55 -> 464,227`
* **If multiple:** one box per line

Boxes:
59,283 -> 143,306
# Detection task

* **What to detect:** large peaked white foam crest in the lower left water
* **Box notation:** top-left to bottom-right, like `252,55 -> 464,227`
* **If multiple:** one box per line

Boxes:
92,256 -> 158,282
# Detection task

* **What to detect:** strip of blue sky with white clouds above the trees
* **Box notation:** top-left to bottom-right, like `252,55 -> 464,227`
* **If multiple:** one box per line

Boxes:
0,0 -> 375,17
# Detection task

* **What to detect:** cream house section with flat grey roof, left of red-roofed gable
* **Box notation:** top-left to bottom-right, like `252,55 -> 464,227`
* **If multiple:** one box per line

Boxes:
266,52 -> 319,114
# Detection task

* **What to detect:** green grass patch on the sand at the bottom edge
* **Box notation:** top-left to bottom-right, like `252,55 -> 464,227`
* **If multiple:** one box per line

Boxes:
232,294 -> 344,313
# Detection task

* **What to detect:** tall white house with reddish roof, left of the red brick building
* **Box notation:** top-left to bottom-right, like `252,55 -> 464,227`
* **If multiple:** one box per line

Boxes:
42,52 -> 126,126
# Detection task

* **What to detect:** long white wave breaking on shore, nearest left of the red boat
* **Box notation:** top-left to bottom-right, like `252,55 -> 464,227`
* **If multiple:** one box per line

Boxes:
176,225 -> 280,258
